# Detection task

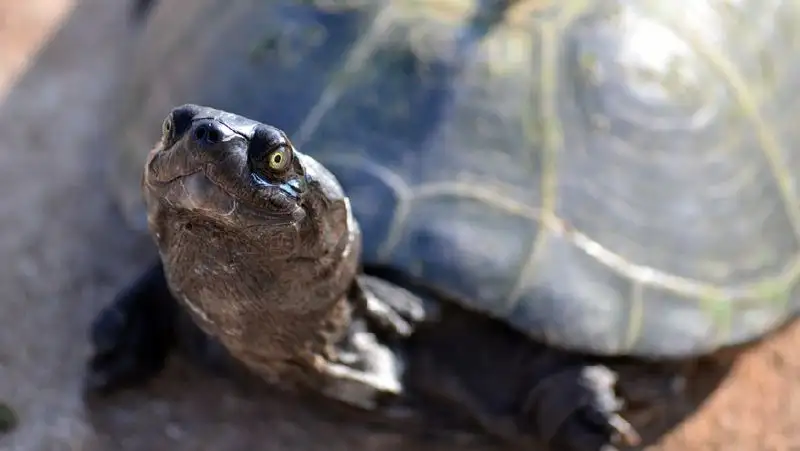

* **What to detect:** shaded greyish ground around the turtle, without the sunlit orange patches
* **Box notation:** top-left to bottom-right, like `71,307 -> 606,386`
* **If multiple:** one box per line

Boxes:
0,0 -> 800,451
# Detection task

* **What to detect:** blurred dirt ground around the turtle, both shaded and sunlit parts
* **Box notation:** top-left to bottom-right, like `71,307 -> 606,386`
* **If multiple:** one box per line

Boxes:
0,0 -> 800,451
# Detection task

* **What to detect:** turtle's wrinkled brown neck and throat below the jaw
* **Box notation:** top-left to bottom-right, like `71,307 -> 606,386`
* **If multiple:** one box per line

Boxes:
143,150 -> 361,366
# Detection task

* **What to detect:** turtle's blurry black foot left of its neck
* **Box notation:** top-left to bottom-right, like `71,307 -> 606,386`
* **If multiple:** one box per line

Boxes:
84,264 -> 177,395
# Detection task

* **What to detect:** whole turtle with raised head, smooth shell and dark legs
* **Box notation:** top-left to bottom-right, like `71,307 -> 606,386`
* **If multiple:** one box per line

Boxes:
87,0 -> 800,451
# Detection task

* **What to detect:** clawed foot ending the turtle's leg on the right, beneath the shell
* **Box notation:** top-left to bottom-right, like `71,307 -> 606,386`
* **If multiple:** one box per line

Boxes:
526,365 -> 641,451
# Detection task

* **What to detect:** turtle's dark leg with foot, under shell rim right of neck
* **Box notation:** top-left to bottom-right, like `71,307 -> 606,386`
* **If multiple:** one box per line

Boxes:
405,306 -> 639,451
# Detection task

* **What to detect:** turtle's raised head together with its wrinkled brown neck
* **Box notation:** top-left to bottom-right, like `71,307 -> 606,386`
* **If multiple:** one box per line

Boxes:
142,105 -> 361,355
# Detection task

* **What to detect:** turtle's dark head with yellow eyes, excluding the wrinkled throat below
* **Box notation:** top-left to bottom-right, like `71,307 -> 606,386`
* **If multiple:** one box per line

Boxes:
142,104 -> 351,257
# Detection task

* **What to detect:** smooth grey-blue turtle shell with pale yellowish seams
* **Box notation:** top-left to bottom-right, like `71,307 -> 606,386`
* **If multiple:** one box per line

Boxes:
113,0 -> 800,357
